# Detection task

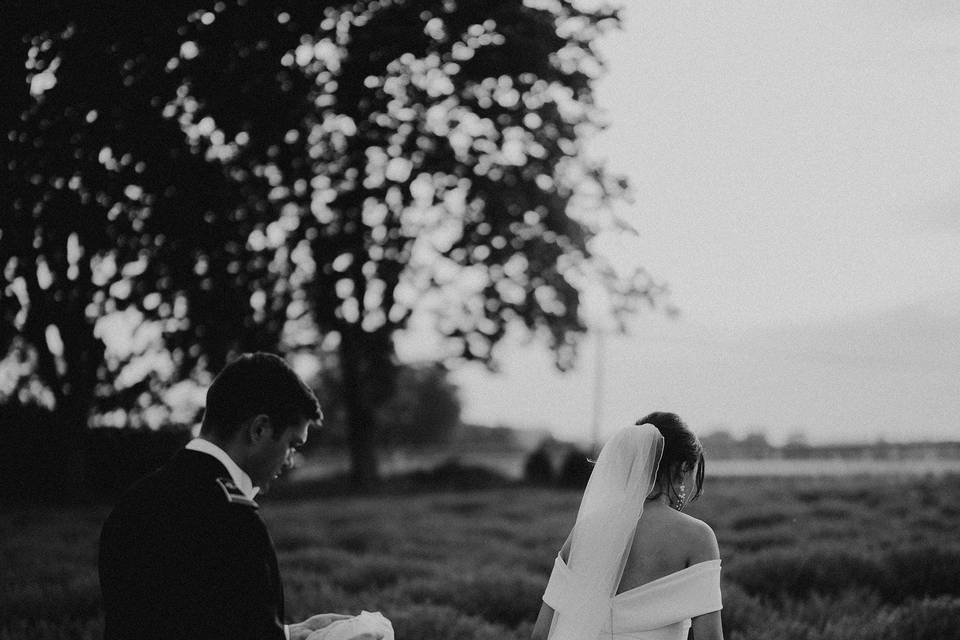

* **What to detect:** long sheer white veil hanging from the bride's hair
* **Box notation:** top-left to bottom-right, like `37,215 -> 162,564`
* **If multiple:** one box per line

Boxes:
548,424 -> 663,640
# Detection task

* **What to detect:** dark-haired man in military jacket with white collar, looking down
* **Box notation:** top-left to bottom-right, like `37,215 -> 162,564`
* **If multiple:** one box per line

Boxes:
100,353 -> 347,640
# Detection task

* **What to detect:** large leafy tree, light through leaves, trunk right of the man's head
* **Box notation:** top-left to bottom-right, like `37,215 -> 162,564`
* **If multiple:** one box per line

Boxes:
0,0 -> 651,483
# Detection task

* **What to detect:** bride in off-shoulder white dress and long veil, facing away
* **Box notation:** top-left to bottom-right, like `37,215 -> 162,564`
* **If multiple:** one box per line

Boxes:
533,412 -> 723,640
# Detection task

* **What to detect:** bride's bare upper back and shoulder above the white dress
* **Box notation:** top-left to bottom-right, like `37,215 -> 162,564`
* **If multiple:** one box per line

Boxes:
617,500 -> 719,593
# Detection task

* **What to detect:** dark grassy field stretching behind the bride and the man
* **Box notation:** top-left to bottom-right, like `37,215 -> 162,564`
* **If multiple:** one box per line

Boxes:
0,476 -> 960,640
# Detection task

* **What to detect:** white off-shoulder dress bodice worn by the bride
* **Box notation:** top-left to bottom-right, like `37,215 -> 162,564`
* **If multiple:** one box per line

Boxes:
543,556 -> 723,640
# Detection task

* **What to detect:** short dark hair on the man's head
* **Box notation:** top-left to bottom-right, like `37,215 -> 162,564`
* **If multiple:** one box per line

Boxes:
200,352 -> 323,439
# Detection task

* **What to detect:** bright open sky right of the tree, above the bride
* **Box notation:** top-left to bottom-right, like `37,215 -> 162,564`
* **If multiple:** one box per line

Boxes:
448,0 -> 960,442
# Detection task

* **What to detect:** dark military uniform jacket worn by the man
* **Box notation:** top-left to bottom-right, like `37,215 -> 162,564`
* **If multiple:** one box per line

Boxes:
100,450 -> 284,640
